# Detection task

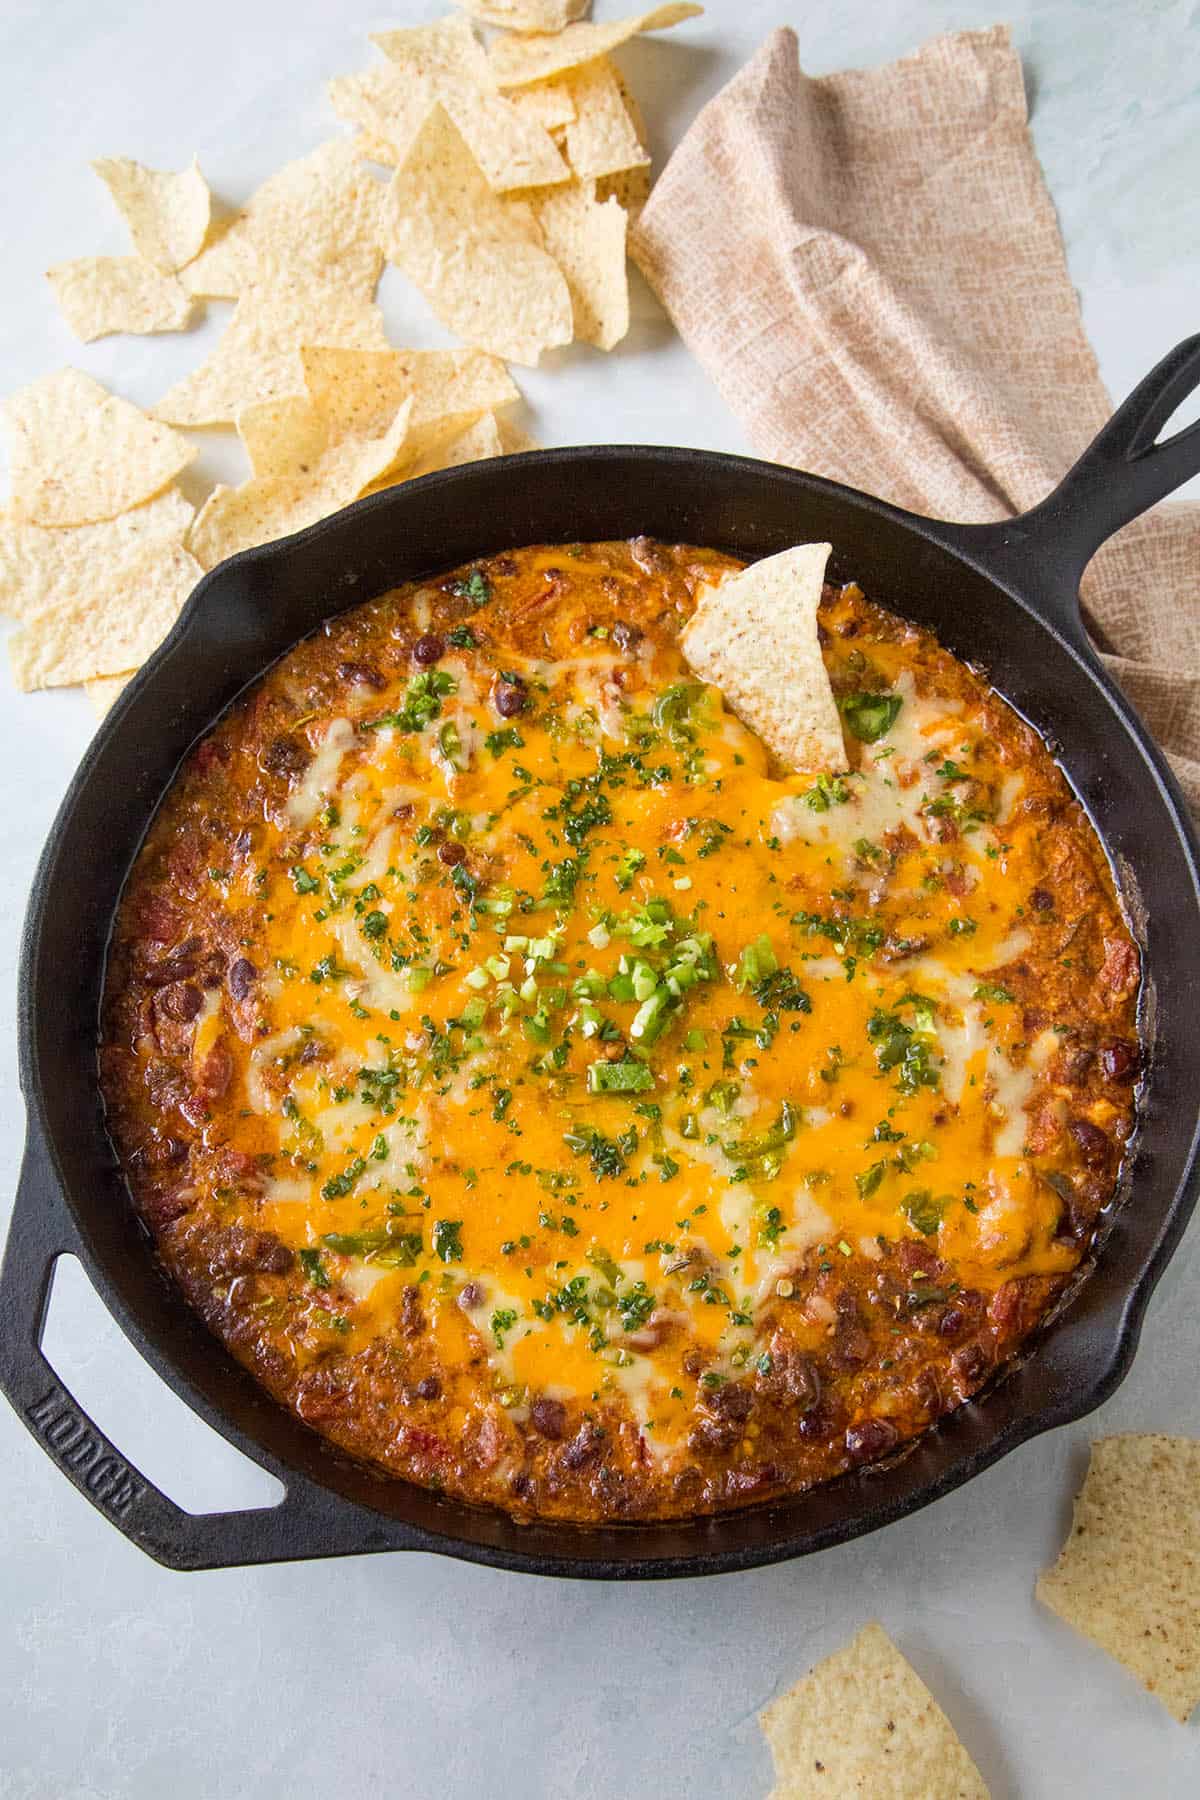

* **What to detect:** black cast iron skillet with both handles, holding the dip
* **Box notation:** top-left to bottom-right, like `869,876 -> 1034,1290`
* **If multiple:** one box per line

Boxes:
0,337 -> 1200,1577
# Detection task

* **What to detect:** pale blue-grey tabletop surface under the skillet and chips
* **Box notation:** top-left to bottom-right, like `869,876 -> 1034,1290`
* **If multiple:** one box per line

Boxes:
0,0 -> 1200,1800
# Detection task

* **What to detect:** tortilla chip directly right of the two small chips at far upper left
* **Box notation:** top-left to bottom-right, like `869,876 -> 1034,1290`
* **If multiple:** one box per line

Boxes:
180,139 -> 385,302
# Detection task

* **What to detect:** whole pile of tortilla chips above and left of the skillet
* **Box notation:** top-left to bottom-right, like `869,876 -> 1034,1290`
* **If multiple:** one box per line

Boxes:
0,0 -> 702,711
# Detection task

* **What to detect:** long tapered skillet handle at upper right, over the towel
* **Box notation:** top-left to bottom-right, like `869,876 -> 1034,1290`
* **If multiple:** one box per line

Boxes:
948,335 -> 1200,653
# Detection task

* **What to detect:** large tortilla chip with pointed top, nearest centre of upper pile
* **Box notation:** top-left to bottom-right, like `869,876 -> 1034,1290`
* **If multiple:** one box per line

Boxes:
385,104 -> 572,364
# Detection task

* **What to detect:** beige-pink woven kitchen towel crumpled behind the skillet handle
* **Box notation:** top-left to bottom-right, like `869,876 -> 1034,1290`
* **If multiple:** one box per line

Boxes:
633,27 -> 1200,808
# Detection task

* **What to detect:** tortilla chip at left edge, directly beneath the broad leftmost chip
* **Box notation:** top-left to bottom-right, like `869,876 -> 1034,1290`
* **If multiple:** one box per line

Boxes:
0,488 -> 193,619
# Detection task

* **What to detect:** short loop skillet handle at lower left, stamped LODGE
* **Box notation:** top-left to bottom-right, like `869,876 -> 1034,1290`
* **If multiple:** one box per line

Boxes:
0,1123 -> 410,1570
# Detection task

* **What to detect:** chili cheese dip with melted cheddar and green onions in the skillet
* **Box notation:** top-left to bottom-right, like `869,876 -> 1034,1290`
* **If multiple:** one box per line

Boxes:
101,538 -> 1139,1521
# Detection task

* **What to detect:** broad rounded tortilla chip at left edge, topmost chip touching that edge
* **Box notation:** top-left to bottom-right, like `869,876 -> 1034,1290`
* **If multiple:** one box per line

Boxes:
4,369 -> 196,526
